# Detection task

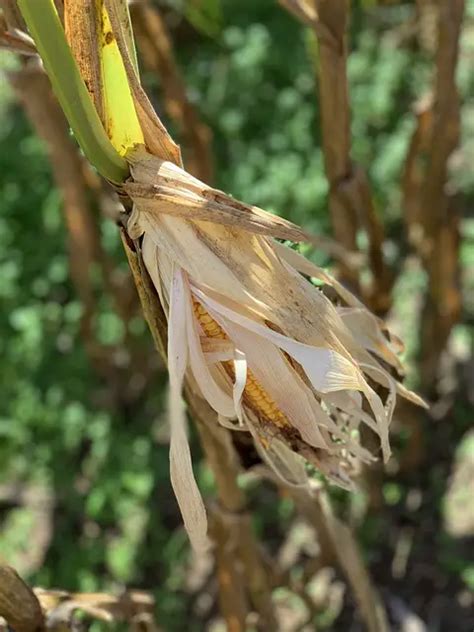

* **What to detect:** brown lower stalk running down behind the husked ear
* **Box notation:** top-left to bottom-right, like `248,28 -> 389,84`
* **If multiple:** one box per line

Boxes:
122,231 -> 276,630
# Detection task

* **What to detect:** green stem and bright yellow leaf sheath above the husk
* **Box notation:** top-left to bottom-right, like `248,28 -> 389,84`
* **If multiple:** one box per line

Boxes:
18,0 -> 143,184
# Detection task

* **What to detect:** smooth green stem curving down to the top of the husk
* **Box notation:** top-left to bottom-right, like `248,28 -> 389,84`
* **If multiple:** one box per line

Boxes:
18,0 -> 128,183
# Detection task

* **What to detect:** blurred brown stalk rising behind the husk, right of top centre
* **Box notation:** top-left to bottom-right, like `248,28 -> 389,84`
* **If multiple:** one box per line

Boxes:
279,0 -> 393,315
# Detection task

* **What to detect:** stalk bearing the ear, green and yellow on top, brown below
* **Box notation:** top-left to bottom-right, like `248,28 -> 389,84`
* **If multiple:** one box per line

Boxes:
12,1 -> 275,630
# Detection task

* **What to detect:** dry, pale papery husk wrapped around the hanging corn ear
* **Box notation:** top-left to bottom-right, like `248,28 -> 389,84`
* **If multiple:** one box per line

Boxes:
125,150 -> 422,546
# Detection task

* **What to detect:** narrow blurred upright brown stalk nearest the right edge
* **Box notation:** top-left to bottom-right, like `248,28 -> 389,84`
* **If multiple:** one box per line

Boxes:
420,0 -> 465,388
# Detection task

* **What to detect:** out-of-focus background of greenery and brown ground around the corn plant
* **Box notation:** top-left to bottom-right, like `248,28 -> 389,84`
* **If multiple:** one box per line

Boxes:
0,0 -> 474,632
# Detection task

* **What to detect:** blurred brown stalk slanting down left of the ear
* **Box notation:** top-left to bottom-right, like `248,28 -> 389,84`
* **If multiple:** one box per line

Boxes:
9,59 -> 144,396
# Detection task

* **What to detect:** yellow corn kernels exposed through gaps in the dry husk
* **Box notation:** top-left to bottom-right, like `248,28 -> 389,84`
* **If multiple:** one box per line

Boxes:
193,298 -> 290,427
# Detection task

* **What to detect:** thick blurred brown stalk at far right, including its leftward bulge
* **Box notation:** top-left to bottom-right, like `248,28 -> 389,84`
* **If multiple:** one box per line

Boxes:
405,0 -> 465,390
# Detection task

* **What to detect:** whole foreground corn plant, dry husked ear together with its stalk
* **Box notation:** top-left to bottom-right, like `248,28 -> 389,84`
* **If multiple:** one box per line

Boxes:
8,0 -> 420,630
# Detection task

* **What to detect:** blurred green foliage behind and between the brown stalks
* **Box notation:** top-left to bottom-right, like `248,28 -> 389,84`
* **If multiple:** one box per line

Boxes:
0,0 -> 474,630
